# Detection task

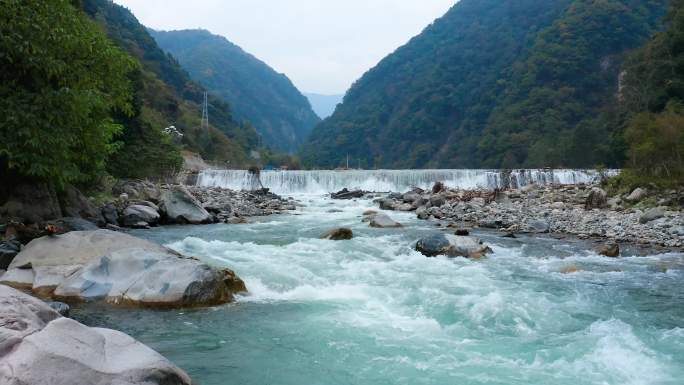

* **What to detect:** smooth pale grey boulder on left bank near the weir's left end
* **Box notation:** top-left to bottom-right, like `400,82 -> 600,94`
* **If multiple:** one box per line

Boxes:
160,186 -> 212,224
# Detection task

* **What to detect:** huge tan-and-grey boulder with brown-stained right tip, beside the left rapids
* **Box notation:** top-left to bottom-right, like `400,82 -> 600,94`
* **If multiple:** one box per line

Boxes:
0,230 -> 245,307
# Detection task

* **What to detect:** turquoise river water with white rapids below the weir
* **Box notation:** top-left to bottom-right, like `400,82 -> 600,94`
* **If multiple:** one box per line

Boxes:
74,195 -> 684,385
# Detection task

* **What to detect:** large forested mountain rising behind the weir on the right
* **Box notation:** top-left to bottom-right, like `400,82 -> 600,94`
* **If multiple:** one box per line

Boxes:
301,0 -> 667,168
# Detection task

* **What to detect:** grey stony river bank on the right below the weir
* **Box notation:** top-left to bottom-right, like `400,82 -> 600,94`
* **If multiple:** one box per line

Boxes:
377,183 -> 684,249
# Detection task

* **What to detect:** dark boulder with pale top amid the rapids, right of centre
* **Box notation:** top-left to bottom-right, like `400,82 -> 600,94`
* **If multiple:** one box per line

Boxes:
416,233 -> 492,259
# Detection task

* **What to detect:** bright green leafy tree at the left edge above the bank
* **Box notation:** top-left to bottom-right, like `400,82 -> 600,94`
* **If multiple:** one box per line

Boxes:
0,0 -> 136,184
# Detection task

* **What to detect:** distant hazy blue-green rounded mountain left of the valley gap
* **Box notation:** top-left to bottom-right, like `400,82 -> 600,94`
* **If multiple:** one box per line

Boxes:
151,30 -> 320,152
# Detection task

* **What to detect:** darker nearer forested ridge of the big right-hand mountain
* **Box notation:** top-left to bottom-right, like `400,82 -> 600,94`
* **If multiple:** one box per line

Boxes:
478,0 -> 666,167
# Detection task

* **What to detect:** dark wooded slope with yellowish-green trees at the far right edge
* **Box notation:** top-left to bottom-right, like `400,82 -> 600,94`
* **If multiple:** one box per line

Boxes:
618,0 -> 684,186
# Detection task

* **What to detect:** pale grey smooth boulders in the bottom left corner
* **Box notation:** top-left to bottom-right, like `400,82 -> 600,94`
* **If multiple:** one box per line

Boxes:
0,285 -> 192,385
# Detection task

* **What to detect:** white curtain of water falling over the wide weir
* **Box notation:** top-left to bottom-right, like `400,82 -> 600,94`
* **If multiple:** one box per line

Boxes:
197,169 -> 617,194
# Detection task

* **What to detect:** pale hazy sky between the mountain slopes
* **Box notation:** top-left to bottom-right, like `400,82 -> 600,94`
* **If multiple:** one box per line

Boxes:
115,0 -> 457,94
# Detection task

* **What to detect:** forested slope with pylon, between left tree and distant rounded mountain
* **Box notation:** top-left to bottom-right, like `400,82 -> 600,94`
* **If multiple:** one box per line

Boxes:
83,0 -> 258,177
